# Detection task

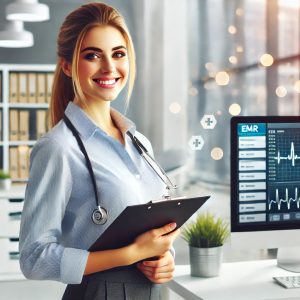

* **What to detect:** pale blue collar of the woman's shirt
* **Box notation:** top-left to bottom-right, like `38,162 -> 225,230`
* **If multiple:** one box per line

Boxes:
65,101 -> 136,140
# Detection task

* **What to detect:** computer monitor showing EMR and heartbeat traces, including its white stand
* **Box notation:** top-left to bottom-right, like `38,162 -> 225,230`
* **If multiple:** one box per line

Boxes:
231,116 -> 300,272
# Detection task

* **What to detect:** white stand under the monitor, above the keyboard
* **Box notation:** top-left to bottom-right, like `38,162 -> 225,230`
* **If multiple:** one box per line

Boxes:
277,247 -> 300,273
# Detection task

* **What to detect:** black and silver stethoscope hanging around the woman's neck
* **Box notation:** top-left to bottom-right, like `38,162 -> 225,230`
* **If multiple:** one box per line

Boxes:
63,114 -> 177,225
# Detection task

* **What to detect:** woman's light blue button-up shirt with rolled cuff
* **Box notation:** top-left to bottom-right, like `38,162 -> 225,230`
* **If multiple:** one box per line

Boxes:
20,102 -> 165,283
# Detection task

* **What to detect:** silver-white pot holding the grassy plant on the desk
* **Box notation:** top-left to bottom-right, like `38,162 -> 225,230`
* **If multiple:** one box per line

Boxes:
190,246 -> 223,277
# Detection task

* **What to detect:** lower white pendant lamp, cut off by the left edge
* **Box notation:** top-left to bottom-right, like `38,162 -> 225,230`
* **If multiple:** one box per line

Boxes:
0,21 -> 33,48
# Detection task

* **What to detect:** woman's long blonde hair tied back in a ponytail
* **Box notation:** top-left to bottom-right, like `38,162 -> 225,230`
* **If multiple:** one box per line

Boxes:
50,3 -> 136,126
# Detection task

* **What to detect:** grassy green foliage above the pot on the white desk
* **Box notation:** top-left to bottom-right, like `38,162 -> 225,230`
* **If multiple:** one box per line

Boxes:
182,213 -> 229,248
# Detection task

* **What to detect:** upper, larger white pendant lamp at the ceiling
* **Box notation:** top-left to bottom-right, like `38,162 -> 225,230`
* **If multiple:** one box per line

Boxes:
6,0 -> 50,22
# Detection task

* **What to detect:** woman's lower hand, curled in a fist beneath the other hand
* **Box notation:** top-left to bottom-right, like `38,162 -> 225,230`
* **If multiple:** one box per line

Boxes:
137,251 -> 175,283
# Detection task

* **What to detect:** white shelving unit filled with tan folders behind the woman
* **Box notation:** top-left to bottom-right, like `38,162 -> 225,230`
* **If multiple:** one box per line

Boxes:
0,64 -> 55,182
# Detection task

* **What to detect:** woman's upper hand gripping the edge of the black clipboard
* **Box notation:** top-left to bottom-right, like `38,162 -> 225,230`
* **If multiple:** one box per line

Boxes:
133,223 -> 180,261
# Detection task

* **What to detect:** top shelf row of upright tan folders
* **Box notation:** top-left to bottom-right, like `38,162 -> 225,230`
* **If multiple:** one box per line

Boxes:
9,72 -> 53,103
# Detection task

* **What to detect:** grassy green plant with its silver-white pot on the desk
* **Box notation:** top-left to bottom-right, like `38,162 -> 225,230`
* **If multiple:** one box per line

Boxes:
182,213 -> 230,277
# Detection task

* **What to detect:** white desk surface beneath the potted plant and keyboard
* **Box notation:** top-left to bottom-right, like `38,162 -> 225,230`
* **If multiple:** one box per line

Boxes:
168,259 -> 300,300
